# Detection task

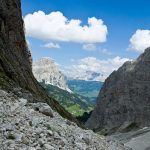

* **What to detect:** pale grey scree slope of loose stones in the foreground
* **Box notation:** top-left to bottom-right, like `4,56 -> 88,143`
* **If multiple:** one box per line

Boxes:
0,90 -> 128,150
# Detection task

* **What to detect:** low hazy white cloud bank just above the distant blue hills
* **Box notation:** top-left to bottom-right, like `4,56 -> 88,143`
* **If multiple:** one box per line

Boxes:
64,56 -> 130,81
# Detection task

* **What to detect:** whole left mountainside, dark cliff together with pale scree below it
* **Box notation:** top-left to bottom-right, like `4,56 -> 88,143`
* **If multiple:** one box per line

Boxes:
0,0 -> 130,150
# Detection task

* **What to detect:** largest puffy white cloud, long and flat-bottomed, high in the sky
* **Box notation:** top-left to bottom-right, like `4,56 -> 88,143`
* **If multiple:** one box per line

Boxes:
24,11 -> 107,43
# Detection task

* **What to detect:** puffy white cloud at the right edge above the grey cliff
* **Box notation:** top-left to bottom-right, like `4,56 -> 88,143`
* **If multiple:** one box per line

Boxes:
129,30 -> 150,52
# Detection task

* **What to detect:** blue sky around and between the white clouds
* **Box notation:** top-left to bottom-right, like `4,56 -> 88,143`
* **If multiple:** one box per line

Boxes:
22,0 -> 150,81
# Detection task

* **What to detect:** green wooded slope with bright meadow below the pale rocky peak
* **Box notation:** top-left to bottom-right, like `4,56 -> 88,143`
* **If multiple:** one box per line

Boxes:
41,83 -> 94,116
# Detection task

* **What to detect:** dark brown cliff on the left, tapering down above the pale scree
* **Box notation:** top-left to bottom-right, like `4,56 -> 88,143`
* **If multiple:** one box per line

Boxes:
0,0 -> 82,126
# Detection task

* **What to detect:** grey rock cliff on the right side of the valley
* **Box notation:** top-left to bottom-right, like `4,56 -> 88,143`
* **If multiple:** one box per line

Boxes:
86,48 -> 150,130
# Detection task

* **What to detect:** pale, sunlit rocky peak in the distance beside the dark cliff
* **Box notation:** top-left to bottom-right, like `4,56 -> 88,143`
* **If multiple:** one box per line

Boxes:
32,57 -> 71,92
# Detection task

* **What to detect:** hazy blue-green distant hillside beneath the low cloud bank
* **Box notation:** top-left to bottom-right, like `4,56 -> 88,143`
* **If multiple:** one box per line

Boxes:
67,80 -> 103,105
